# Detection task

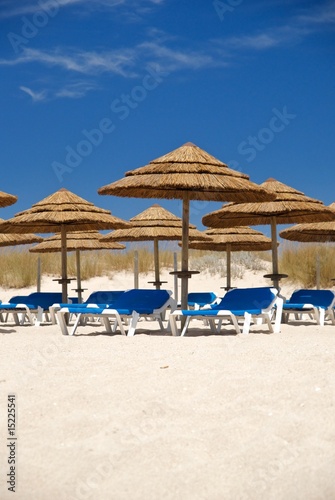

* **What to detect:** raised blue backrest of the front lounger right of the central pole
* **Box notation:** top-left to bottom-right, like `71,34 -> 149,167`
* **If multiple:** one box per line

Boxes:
212,287 -> 275,311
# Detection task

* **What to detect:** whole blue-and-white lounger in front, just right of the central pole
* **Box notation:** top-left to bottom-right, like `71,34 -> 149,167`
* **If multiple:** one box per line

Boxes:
170,287 -> 283,335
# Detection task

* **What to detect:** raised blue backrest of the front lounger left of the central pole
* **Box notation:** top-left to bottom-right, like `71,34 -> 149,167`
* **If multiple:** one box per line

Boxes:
113,288 -> 170,313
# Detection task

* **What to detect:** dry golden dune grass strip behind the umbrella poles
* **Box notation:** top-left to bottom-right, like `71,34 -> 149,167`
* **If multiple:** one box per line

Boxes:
0,242 -> 335,288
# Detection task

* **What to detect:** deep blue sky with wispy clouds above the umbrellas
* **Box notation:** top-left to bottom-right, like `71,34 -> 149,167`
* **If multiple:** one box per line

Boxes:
0,0 -> 335,238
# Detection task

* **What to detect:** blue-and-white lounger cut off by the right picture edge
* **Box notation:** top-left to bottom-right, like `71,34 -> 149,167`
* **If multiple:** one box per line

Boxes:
283,289 -> 335,326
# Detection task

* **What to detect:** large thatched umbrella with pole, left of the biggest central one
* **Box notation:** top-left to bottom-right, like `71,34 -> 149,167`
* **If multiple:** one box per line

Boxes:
0,188 -> 128,302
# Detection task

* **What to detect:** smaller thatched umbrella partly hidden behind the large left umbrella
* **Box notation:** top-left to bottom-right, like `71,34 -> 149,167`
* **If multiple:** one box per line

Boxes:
28,231 -> 126,303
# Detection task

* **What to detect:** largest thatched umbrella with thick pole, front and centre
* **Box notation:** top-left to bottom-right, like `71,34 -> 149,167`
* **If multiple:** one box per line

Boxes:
98,143 -> 272,309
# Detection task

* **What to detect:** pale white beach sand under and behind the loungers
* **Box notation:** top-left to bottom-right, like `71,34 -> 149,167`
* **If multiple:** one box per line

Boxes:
0,272 -> 335,500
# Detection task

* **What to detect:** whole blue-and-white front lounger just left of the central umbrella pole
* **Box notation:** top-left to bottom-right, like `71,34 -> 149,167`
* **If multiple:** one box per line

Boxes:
57,289 -> 177,336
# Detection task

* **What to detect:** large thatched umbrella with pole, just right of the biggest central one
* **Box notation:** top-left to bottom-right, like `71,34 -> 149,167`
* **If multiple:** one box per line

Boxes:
202,179 -> 335,288
